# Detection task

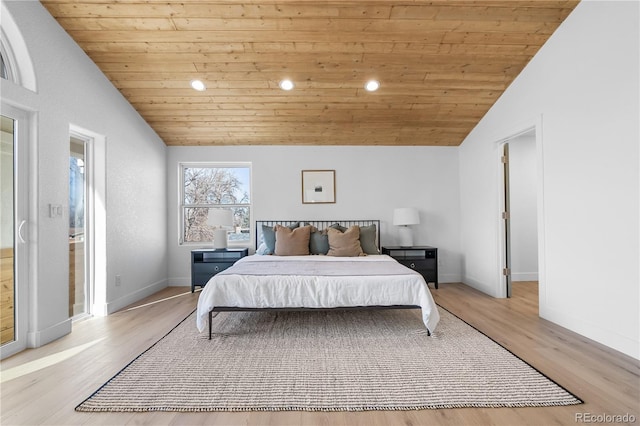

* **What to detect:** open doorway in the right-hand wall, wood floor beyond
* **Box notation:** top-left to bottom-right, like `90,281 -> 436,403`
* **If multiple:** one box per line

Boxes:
503,129 -> 539,297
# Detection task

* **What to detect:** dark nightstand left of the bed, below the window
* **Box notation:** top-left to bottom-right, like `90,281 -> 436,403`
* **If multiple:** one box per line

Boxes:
191,248 -> 249,293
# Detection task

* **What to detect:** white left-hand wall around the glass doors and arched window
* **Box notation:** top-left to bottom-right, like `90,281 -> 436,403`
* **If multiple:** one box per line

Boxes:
1,1 -> 167,345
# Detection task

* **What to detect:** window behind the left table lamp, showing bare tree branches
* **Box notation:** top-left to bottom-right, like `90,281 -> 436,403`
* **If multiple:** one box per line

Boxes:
180,163 -> 251,244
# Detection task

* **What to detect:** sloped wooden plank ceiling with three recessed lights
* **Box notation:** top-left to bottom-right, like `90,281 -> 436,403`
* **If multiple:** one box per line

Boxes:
42,0 -> 578,146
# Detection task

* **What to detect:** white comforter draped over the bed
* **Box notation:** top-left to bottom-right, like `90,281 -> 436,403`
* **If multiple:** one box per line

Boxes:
196,255 -> 440,332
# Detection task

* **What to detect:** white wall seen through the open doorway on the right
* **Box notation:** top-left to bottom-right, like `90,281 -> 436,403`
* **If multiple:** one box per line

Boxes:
509,132 -> 538,281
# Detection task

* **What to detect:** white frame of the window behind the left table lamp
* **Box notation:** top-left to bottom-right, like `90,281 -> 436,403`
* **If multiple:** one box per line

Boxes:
178,161 -> 255,247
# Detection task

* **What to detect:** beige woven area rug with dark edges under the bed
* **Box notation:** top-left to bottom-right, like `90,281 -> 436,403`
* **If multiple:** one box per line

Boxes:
76,308 -> 582,411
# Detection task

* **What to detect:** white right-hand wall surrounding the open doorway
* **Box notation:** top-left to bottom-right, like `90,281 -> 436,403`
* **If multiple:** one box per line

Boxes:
459,1 -> 640,358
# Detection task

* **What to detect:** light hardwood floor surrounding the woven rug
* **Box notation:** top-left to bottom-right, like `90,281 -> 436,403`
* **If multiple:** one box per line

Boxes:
0,283 -> 640,426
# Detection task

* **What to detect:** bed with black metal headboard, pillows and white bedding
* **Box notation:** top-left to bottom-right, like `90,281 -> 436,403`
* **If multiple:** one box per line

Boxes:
196,220 -> 440,338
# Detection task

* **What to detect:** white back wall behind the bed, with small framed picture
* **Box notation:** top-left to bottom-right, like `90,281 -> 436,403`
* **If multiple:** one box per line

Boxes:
167,146 -> 460,285
